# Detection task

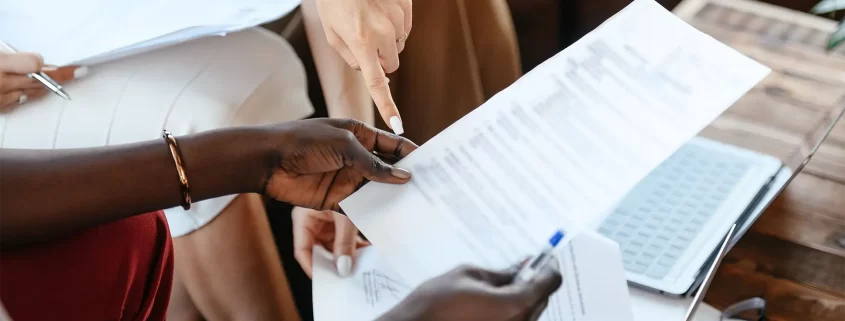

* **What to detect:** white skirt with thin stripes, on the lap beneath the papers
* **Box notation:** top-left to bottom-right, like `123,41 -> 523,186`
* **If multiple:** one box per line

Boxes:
0,28 -> 313,148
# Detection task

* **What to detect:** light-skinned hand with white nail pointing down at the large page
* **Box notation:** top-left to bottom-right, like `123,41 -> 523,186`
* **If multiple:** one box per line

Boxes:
314,0 -> 412,134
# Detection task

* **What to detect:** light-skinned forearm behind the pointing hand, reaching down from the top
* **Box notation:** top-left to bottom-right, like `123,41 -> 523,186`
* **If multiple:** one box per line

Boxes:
302,0 -> 375,125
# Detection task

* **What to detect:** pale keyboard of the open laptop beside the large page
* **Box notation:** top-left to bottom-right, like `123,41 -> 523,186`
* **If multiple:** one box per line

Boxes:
598,143 -> 753,279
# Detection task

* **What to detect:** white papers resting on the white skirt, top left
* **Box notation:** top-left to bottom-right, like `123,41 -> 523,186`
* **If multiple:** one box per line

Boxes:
0,0 -> 300,66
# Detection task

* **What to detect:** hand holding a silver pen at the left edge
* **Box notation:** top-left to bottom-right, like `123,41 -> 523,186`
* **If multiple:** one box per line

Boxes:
0,52 -> 88,112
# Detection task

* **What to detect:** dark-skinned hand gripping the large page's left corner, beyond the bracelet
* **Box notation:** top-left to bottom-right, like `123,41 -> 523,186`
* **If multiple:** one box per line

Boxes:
264,119 -> 417,211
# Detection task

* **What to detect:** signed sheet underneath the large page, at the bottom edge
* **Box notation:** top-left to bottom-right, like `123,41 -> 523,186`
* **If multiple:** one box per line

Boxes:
312,233 -> 633,321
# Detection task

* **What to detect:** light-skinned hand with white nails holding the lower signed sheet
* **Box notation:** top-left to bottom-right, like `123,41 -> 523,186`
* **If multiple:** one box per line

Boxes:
291,207 -> 370,277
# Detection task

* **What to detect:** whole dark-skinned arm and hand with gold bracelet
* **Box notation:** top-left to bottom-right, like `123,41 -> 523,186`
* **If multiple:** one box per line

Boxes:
0,119 -> 416,246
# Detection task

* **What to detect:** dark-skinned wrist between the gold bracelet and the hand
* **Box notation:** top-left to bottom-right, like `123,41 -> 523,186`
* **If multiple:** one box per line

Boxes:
177,127 -> 274,201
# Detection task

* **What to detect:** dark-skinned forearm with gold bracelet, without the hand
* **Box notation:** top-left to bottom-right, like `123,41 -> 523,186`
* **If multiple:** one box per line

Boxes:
0,129 -> 269,245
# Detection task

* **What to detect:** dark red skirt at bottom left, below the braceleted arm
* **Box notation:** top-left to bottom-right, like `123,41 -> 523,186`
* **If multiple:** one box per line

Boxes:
0,212 -> 173,321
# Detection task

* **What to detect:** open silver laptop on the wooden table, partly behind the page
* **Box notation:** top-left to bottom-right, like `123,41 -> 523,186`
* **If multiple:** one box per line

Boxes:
598,108 -> 845,297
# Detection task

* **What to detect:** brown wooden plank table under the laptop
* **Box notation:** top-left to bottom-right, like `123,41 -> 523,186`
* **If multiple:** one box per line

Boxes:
674,0 -> 845,321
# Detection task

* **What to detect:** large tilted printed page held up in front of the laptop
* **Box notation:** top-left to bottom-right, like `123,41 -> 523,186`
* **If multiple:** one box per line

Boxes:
341,0 -> 770,285
